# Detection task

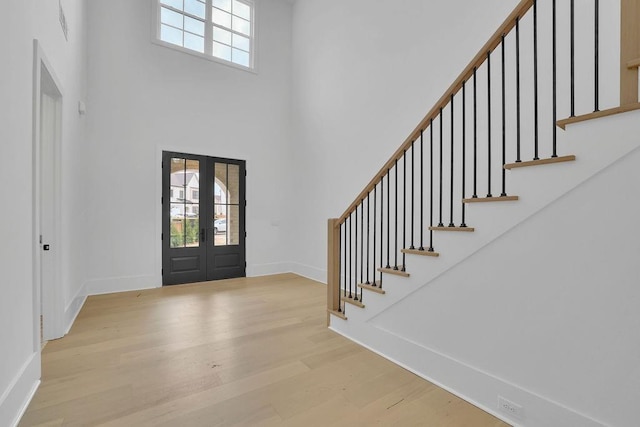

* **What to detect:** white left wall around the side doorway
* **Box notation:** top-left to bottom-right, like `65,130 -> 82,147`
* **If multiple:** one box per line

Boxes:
0,0 -> 86,425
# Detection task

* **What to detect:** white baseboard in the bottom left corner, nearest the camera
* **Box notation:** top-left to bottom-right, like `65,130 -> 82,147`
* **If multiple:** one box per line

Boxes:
0,352 -> 40,427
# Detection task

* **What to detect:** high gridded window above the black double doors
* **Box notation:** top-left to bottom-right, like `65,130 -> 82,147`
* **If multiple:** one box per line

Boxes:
158,0 -> 254,68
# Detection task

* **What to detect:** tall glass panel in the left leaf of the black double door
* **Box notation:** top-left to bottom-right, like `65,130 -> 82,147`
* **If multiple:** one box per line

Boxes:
169,158 -> 200,248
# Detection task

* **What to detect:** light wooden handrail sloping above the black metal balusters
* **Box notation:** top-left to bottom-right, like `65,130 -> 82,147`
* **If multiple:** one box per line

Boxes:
335,0 -> 534,227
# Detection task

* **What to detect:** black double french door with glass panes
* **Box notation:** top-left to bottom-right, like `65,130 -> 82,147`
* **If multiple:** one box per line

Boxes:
162,151 -> 246,285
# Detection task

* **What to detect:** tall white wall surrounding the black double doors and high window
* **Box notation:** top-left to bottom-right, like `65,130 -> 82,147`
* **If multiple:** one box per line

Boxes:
84,0 -> 292,293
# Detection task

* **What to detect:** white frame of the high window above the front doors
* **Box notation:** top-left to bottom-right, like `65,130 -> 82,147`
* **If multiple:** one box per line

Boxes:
150,0 -> 258,74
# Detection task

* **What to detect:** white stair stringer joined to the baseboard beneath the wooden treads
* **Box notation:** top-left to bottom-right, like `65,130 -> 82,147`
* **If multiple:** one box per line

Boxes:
332,112 -> 640,426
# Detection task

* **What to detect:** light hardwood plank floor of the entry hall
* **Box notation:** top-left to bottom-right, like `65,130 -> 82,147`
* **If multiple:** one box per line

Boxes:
20,274 -> 507,427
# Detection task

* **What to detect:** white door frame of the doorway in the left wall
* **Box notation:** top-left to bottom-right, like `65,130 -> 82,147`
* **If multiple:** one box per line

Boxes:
31,39 -> 64,346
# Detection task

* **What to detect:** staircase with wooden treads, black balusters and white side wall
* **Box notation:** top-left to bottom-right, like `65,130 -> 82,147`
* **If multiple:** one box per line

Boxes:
327,0 -> 640,426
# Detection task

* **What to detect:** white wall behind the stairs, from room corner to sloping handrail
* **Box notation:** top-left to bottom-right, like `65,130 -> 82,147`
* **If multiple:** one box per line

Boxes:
292,0 -> 518,281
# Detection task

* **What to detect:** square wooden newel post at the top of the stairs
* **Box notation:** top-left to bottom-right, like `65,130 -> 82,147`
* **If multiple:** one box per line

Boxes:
620,0 -> 640,106
